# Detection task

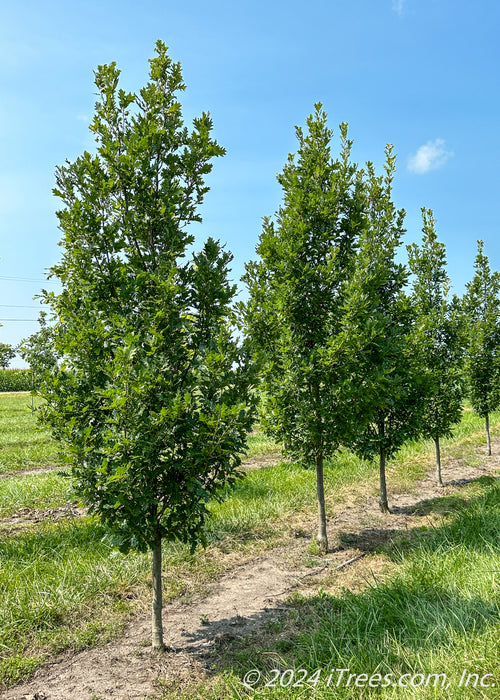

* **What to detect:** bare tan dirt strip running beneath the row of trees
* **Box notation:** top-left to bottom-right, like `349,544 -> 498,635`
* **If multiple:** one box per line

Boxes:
0,440 -> 500,700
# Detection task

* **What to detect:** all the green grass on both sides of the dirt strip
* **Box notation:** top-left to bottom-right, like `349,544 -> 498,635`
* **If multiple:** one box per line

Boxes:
0,394 -> 500,700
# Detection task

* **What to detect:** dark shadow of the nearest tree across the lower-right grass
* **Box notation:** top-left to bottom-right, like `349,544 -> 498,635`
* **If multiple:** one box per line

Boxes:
175,579 -> 500,699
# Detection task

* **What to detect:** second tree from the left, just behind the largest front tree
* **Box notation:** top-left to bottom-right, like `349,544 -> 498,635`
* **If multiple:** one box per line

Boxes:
244,104 -> 362,552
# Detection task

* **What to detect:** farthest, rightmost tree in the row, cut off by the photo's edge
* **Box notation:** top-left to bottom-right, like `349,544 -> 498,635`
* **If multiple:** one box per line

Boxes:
463,241 -> 500,455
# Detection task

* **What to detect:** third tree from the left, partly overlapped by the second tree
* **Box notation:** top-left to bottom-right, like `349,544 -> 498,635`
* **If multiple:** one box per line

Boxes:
346,146 -> 421,513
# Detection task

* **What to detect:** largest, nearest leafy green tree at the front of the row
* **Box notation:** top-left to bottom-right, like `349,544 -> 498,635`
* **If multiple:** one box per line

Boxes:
33,41 -> 254,649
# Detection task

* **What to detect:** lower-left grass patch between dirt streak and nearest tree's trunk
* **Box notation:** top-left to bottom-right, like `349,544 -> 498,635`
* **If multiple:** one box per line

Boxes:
0,518 -> 147,684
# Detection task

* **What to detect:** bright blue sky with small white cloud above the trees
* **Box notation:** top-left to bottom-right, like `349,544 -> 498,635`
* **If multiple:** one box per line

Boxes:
0,0 -> 500,366
